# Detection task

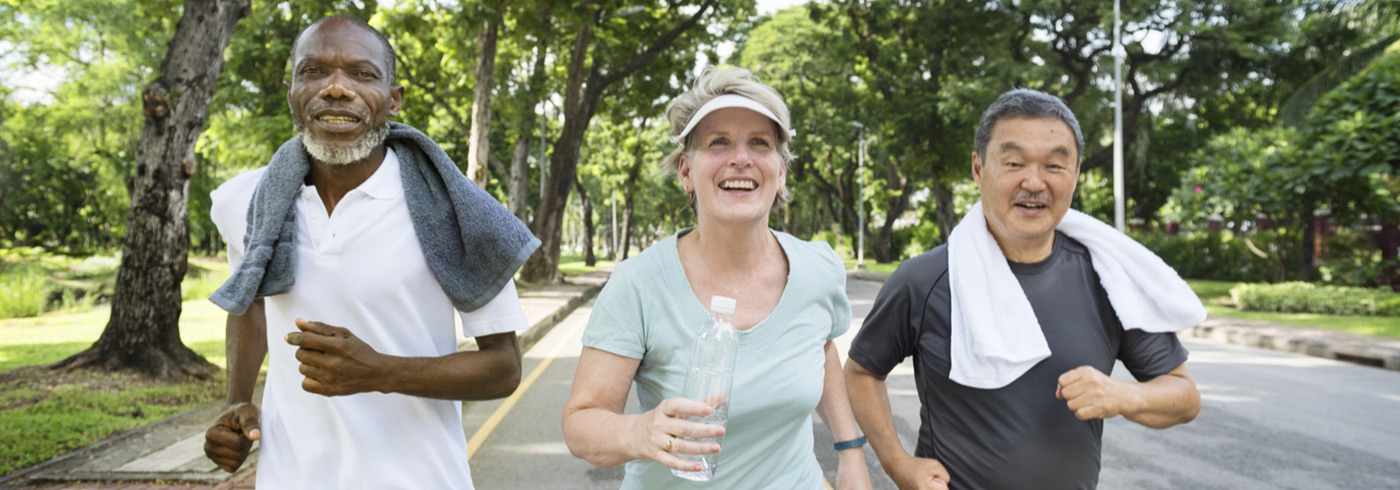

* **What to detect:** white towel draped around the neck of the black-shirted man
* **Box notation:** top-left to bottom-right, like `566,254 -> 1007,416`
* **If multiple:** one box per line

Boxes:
948,202 -> 1205,389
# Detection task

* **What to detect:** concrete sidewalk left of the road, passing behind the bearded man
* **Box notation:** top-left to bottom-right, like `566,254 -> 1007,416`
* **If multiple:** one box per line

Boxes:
0,269 -> 612,490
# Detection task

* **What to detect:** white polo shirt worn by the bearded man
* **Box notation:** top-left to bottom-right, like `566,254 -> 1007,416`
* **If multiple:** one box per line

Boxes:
210,150 -> 528,490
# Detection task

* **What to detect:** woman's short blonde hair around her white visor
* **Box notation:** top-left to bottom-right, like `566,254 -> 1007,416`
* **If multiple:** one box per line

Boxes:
661,64 -> 792,206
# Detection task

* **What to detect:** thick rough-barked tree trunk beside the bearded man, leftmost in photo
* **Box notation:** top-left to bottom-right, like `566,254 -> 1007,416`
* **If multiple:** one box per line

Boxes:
53,0 -> 249,381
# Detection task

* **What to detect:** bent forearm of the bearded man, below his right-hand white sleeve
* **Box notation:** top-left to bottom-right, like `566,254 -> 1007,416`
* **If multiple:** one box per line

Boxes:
375,332 -> 521,400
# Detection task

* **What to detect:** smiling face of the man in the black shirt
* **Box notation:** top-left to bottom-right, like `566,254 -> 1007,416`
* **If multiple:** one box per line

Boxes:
972,118 -> 1079,262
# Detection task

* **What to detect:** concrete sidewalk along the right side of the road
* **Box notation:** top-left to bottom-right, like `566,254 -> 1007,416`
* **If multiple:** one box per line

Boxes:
847,270 -> 1400,371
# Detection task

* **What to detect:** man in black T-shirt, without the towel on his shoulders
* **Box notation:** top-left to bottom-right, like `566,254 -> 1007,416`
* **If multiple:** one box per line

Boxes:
846,90 -> 1200,489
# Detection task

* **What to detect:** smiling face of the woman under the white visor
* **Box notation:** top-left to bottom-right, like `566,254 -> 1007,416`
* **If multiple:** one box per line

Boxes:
679,108 -> 787,225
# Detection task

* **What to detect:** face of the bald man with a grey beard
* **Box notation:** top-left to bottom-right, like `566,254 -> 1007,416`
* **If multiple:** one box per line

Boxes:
287,20 -> 403,165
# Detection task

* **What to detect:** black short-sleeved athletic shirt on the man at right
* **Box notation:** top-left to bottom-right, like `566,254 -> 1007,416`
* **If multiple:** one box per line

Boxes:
850,232 -> 1187,489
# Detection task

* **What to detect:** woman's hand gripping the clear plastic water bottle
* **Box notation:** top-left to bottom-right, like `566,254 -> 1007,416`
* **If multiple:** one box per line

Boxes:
630,395 -> 724,472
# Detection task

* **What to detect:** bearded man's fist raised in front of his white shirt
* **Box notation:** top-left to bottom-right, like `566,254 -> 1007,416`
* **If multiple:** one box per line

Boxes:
287,318 -> 388,396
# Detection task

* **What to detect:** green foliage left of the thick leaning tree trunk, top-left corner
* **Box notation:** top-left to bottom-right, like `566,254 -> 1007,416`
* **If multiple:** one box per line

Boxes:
0,0 -> 179,248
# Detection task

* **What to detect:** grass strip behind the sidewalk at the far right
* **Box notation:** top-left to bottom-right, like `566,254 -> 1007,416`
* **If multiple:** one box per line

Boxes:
1186,279 -> 1400,339
